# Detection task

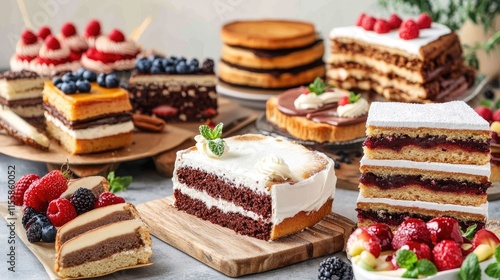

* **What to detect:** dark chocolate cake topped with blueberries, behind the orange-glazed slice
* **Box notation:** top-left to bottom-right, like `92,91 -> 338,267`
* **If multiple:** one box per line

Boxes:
129,56 -> 218,122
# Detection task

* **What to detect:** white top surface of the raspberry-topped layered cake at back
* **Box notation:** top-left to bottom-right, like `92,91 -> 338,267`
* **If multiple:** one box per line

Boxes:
330,22 -> 451,54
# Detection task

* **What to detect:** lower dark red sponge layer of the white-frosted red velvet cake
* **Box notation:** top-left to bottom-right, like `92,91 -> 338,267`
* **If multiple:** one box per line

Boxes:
174,190 -> 272,240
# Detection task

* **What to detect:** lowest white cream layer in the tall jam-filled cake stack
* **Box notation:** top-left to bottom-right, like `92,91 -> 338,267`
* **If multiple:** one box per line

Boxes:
357,193 -> 488,218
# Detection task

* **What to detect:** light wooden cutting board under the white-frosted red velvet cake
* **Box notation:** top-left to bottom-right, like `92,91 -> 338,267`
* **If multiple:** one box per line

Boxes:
137,196 -> 355,277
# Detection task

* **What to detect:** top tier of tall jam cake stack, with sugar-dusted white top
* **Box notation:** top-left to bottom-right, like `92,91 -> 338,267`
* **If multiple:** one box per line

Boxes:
363,101 -> 491,165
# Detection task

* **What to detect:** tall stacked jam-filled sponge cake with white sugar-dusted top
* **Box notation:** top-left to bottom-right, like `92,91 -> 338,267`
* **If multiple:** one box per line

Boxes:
356,101 -> 491,228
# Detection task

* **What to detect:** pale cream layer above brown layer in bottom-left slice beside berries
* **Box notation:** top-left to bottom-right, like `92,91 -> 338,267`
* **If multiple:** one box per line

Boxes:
59,220 -> 144,256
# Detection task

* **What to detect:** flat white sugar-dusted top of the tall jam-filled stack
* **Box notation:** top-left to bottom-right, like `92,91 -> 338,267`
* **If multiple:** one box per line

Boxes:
366,101 -> 489,130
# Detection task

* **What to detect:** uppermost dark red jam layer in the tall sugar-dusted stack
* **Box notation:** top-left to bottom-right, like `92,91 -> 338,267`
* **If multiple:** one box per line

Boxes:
363,135 -> 490,153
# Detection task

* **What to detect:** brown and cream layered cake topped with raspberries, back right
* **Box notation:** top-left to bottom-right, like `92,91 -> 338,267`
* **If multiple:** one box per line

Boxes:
327,15 -> 474,103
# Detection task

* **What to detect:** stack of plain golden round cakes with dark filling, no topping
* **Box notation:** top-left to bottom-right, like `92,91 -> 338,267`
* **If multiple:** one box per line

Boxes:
218,20 -> 325,88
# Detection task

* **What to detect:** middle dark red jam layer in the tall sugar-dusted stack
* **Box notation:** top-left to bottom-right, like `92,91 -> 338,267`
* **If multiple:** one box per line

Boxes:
359,172 -> 491,195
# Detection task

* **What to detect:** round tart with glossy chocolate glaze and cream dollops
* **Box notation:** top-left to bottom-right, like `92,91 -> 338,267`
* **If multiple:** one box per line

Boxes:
266,78 -> 369,143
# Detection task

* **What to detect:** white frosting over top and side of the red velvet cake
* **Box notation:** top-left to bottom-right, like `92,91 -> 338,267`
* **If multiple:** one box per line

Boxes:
172,135 -> 337,225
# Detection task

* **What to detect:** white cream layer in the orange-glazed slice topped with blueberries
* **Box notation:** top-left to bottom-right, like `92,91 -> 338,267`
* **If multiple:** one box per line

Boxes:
44,112 -> 134,139
